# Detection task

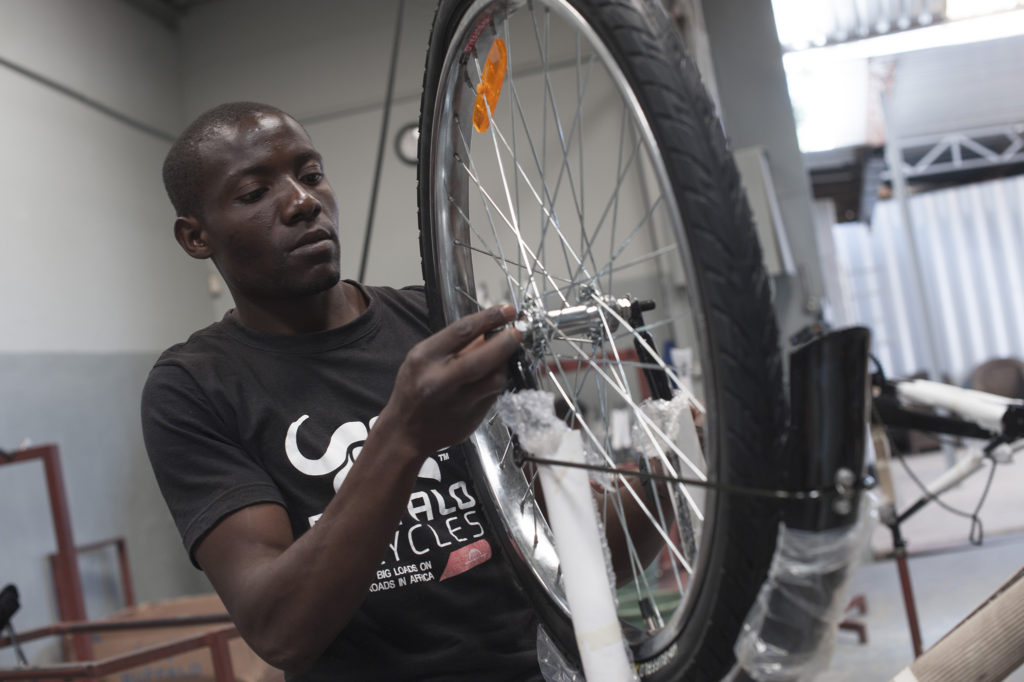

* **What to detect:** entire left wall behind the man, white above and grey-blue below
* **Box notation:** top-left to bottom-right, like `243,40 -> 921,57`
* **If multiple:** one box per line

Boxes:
0,0 -> 212,666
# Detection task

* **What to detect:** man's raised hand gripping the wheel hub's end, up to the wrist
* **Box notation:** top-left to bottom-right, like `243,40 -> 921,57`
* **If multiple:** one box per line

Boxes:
374,304 -> 520,457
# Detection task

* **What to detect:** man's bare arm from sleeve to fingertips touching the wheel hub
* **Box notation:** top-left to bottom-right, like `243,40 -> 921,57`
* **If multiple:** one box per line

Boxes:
196,306 -> 519,671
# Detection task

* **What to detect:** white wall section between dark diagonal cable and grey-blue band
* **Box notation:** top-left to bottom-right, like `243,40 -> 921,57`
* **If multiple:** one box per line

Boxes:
0,69 -> 216,352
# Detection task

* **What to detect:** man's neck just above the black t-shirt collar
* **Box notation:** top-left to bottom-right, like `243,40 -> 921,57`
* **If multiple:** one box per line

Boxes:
234,281 -> 367,334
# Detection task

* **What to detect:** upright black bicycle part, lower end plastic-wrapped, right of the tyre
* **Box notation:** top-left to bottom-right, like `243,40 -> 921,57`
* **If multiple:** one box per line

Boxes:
727,328 -> 869,681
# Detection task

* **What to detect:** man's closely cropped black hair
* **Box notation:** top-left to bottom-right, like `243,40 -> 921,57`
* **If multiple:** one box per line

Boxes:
164,101 -> 291,216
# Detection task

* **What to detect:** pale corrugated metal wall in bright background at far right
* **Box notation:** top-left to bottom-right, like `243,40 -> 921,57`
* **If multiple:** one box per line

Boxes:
833,176 -> 1024,383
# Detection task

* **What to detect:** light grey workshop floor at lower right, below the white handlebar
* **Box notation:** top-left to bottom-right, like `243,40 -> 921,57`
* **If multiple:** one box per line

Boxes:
819,446 -> 1024,682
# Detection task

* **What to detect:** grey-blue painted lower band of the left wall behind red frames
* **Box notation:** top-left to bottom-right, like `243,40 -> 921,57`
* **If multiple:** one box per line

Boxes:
0,353 -> 210,667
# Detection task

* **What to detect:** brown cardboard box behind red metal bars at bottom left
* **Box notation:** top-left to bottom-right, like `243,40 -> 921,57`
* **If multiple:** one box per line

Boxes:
90,594 -> 285,682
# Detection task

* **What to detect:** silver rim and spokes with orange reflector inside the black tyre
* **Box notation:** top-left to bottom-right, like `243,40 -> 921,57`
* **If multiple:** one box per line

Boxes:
428,0 -> 717,645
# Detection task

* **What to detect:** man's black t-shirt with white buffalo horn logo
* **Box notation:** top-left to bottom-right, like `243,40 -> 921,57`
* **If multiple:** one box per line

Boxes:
142,280 -> 540,681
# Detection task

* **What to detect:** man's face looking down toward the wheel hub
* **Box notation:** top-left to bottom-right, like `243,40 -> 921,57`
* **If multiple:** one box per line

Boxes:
199,114 -> 341,303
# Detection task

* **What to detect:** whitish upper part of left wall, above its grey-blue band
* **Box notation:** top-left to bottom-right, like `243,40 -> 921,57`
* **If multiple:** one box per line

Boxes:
0,0 -> 210,352
